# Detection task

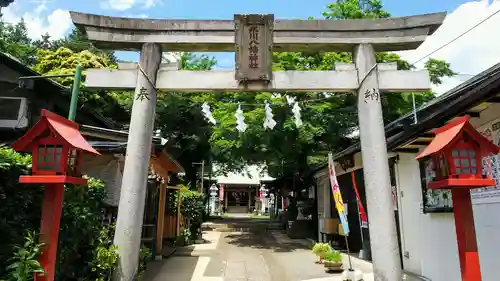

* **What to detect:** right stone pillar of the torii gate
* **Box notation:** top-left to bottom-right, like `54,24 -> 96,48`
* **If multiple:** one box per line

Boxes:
353,44 -> 402,281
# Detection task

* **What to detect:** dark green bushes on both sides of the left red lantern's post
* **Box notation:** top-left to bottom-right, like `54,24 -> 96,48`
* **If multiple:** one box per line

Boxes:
0,147 -> 152,281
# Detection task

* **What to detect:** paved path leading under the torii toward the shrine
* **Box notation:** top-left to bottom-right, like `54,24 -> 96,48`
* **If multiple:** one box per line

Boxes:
144,218 -> 422,281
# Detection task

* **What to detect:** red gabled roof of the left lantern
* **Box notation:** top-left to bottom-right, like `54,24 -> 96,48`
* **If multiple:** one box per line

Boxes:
12,109 -> 100,155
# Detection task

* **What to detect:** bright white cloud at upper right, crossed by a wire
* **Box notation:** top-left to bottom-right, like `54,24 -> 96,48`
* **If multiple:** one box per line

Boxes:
398,0 -> 500,93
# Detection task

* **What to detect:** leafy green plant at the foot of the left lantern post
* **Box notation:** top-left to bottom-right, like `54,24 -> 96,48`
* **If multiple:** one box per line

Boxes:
2,232 -> 45,281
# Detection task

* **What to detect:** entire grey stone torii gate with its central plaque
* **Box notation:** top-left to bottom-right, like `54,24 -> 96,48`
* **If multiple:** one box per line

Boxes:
71,12 -> 445,281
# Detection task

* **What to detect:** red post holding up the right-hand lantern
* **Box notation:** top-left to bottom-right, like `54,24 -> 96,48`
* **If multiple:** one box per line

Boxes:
451,189 -> 481,281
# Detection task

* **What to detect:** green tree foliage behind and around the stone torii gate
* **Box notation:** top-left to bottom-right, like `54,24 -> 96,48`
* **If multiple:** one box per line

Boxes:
0,0 -> 455,184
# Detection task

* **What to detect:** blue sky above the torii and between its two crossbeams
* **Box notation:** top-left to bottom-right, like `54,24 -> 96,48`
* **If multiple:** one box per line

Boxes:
47,0 -> 463,68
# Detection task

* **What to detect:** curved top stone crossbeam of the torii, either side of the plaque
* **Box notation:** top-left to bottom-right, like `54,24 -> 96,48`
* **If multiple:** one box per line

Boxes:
70,12 -> 446,52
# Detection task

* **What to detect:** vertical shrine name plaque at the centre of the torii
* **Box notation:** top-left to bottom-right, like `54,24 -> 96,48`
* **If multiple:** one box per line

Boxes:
234,14 -> 274,85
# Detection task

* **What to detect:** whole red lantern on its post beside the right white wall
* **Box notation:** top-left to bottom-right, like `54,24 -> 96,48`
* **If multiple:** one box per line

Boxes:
416,116 -> 500,281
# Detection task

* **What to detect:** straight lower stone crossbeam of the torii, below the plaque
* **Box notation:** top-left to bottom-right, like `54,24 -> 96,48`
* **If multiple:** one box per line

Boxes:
86,63 -> 431,92
